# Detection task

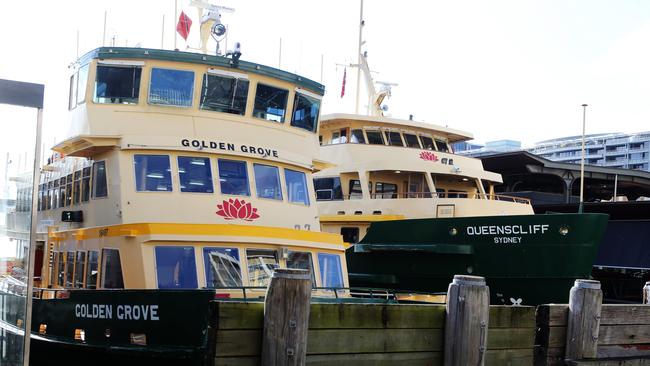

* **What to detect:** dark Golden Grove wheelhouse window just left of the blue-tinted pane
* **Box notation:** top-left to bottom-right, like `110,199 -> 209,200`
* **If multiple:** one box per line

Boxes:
93,66 -> 142,104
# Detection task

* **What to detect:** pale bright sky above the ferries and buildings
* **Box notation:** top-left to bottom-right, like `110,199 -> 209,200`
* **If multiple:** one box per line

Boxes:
0,0 -> 650,147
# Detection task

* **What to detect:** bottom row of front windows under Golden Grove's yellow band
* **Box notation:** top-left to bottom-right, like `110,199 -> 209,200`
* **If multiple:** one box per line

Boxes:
155,246 -> 344,289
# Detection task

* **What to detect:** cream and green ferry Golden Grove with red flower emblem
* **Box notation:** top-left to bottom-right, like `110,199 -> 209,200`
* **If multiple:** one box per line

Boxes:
5,47 -> 349,364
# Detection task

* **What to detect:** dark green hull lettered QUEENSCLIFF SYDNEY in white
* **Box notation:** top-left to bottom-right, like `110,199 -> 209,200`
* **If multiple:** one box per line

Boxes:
346,214 -> 608,305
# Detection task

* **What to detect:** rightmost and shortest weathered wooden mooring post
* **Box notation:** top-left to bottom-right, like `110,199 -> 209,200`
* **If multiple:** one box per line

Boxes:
564,280 -> 603,360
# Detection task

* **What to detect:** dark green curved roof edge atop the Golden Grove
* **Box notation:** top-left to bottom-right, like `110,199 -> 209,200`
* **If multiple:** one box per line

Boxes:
79,47 -> 325,95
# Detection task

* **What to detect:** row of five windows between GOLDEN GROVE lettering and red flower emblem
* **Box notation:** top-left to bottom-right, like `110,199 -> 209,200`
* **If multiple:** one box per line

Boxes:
133,155 -> 309,205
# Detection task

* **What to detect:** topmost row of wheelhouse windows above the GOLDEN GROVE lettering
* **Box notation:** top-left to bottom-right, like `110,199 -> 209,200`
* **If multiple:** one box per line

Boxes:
69,65 -> 320,132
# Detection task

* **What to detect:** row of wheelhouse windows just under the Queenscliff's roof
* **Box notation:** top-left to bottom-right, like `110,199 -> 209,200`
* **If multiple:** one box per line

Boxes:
319,128 -> 450,152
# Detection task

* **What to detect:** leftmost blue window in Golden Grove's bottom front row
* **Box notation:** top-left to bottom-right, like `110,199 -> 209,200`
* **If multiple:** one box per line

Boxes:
156,247 -> 199,288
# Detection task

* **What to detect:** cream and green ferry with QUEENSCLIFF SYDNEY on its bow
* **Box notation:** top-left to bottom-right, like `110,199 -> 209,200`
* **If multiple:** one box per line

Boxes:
314,25 -> 607,304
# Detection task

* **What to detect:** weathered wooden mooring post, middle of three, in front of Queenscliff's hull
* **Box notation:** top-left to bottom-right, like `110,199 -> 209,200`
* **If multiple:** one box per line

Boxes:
445,275 -> 490,366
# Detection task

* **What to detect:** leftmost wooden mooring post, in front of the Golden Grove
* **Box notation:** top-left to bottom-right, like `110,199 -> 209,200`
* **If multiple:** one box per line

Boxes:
262,269 -> 311,366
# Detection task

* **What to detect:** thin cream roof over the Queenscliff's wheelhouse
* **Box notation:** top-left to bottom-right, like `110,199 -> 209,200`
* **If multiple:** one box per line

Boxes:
321,113 -> 474,143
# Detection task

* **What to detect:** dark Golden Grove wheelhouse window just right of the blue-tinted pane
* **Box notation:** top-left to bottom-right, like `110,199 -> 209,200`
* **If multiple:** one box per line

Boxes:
200,74 -> 248,116
